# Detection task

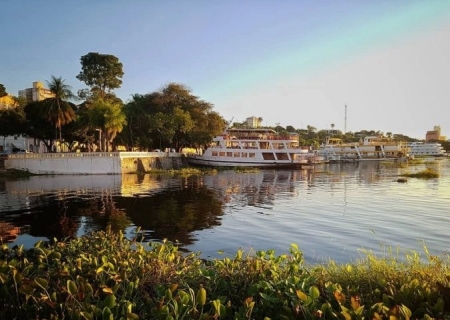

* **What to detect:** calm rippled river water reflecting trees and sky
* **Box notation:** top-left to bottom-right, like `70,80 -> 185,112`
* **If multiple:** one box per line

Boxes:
0,159 -> 450,263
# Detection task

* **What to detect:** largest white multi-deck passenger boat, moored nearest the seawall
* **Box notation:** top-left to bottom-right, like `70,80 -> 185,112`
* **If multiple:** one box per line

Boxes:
187,128 -> 320,167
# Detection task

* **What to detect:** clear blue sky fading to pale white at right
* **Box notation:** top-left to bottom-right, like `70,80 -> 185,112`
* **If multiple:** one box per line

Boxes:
0,0 -> 450,139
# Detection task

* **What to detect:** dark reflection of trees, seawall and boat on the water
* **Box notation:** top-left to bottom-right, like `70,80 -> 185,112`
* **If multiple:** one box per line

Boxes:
0,170 -> 311,246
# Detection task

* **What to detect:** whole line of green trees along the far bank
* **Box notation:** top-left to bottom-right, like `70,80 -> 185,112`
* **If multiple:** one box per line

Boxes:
0,52 -> 446,151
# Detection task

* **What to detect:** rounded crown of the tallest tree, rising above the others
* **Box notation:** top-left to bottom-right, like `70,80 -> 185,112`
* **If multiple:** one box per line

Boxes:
77,52 -> 123,98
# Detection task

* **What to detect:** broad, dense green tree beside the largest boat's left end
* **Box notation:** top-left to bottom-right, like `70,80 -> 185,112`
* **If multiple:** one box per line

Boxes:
124,83 -> 226,149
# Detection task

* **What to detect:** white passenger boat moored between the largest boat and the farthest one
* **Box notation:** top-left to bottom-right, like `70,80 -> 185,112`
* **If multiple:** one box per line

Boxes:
318,136 -> 409,162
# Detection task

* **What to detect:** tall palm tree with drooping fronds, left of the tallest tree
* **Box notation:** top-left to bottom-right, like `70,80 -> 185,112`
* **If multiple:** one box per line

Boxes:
42,75 -> 77,146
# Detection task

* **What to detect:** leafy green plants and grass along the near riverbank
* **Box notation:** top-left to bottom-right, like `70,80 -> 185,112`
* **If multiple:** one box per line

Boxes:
0,230 -> 450,319
